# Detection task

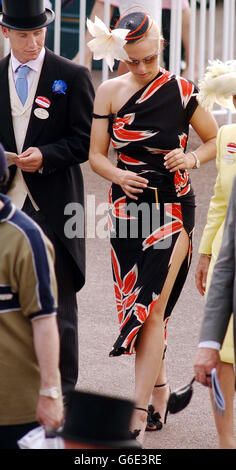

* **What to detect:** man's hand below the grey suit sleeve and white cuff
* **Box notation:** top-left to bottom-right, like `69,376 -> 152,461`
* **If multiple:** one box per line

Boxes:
194,348 -> 220,387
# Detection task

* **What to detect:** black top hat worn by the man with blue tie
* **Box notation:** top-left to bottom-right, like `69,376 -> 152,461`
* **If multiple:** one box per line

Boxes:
0,0 -> 55,31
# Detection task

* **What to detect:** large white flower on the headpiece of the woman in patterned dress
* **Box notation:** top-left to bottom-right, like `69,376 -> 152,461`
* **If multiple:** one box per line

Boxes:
87,16 -> 130,70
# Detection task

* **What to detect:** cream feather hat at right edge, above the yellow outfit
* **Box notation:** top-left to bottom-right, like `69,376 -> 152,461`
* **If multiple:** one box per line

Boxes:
197,60 -> 236,111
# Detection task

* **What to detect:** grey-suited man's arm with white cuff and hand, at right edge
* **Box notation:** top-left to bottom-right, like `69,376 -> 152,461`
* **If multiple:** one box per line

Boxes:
194,178 -> 236,386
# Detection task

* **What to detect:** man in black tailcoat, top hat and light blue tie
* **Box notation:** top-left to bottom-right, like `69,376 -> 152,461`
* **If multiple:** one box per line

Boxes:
0,0 -> 94,394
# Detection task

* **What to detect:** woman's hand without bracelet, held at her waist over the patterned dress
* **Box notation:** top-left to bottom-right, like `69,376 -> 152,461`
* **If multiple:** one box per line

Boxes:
115,168 -> 148,200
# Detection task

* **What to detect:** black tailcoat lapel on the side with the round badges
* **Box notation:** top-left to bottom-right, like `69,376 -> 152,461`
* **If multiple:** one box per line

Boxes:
23,48 -> 58,150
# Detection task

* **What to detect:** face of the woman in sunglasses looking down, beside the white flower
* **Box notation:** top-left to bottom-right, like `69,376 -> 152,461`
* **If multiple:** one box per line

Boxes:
125,39 -> 159,84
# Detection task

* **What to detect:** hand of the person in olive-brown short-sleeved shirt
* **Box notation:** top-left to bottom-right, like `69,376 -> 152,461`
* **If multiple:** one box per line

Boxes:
36,395 -> 64,429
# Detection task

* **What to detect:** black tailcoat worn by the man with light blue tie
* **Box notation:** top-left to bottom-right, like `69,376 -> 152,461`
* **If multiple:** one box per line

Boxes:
0,49 -> 94,290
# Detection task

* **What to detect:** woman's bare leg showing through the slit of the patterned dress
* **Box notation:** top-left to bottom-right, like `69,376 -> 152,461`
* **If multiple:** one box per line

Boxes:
132,229 -> 189,442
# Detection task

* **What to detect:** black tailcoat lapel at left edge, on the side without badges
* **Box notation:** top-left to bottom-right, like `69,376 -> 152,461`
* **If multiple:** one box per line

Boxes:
0,54 -> 16,152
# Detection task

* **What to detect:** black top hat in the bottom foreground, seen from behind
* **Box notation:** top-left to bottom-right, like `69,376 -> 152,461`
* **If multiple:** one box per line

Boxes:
55,390 -> 141,449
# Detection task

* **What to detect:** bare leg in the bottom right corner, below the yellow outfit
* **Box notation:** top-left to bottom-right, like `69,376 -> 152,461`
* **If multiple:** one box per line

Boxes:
210,362 -> 236,449
